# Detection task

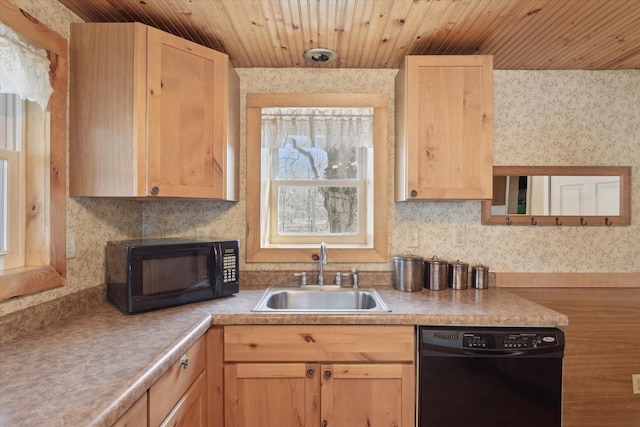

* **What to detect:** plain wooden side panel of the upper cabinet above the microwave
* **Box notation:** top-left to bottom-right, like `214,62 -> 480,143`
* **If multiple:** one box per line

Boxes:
69,23 -> 149,197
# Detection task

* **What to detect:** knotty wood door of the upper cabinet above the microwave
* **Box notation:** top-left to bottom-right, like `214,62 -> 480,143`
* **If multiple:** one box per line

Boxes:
146,28 -> 226,198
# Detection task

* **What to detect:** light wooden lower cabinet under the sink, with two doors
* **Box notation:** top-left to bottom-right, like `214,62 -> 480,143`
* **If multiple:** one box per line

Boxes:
224,325 -> 415,427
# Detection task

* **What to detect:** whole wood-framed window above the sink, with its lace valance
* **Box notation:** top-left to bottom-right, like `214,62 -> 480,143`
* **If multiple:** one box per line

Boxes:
247,94 -> 388,262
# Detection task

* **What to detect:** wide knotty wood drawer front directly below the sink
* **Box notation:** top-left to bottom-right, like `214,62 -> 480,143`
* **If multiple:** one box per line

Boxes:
224,325 -> 415,362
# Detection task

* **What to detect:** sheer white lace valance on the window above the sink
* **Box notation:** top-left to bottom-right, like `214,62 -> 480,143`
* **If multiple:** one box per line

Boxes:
262,108 -> 373,149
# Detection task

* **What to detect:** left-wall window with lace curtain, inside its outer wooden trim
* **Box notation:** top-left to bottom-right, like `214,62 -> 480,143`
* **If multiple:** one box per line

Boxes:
0,22 -> 53,270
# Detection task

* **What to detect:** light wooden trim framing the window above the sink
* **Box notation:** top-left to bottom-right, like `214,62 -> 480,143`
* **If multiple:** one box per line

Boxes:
246,93 -> 389,263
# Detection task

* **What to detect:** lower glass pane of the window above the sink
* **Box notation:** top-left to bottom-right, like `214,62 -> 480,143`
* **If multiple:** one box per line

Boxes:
278,185 -> 359,235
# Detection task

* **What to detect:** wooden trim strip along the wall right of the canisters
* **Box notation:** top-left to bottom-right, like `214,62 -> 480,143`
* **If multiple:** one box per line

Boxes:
495,272 -> 640,288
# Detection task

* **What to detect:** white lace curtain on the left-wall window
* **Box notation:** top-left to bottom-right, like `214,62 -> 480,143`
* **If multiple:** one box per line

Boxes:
0,22 -> 53,110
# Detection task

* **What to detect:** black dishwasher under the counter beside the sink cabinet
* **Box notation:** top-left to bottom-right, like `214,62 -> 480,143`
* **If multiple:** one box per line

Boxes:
418,326 -> 564,427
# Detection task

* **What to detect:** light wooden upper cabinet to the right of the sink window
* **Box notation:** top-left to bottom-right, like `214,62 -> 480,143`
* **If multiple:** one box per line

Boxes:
395,55 -> 493,201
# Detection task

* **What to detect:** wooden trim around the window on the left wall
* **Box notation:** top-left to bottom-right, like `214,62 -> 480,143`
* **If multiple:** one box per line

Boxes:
0,0 -> 68,301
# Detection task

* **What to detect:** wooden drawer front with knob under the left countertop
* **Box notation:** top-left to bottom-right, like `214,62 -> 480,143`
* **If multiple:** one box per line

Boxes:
149,337 -> 206,426
